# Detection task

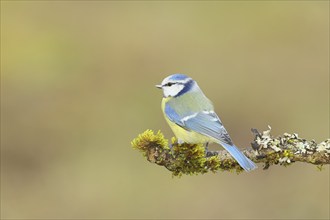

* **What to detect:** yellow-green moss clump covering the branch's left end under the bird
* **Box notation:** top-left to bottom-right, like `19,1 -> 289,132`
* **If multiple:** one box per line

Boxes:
131,130 -> 236,176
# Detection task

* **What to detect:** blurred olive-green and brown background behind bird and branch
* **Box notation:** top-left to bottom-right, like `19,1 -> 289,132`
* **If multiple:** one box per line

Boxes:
1,1 -> 329,219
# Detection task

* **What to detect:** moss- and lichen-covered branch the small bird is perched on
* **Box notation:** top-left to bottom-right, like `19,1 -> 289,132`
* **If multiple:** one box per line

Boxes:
131,127 -> 330,176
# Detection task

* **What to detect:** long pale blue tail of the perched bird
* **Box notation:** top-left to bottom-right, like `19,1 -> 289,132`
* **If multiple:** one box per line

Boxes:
220,143 -> 257,172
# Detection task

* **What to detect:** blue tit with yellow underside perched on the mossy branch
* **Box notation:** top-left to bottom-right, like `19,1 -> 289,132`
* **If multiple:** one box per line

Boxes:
156,74 -> 257,171
